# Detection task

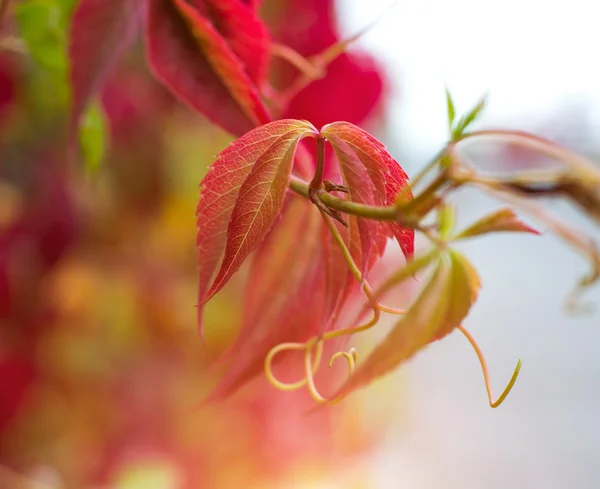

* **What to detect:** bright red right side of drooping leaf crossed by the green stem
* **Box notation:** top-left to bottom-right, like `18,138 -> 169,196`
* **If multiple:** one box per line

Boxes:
321,122 -> 415,259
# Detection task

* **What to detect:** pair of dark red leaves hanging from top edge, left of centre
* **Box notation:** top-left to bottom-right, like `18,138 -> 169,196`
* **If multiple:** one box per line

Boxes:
69,0 -> 270,135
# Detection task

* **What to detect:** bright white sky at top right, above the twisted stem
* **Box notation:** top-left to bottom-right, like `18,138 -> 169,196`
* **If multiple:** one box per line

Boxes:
338,0 -> 600,161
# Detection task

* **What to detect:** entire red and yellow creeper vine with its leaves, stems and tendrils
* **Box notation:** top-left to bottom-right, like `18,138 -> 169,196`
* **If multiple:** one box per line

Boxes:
5,0 -> 600,407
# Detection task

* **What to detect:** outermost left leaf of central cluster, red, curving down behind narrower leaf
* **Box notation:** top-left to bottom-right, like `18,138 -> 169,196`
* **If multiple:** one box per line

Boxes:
196,120 -> 314,330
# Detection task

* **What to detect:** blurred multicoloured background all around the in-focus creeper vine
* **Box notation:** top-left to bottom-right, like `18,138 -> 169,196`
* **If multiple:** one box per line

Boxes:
0,0 -> 600,489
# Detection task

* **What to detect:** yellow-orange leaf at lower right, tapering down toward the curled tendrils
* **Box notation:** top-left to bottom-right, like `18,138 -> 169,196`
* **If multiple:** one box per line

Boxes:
333,250 -> 479,398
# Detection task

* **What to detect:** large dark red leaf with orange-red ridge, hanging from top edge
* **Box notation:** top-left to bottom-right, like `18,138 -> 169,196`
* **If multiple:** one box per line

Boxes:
147,0 -> 269,135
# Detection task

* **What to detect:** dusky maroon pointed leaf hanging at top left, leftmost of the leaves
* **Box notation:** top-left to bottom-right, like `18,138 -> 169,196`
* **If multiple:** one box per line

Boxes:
69,0 -> 143,141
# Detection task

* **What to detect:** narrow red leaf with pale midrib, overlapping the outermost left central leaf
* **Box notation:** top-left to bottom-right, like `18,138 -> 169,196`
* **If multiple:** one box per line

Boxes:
204,121 -> 316,302
